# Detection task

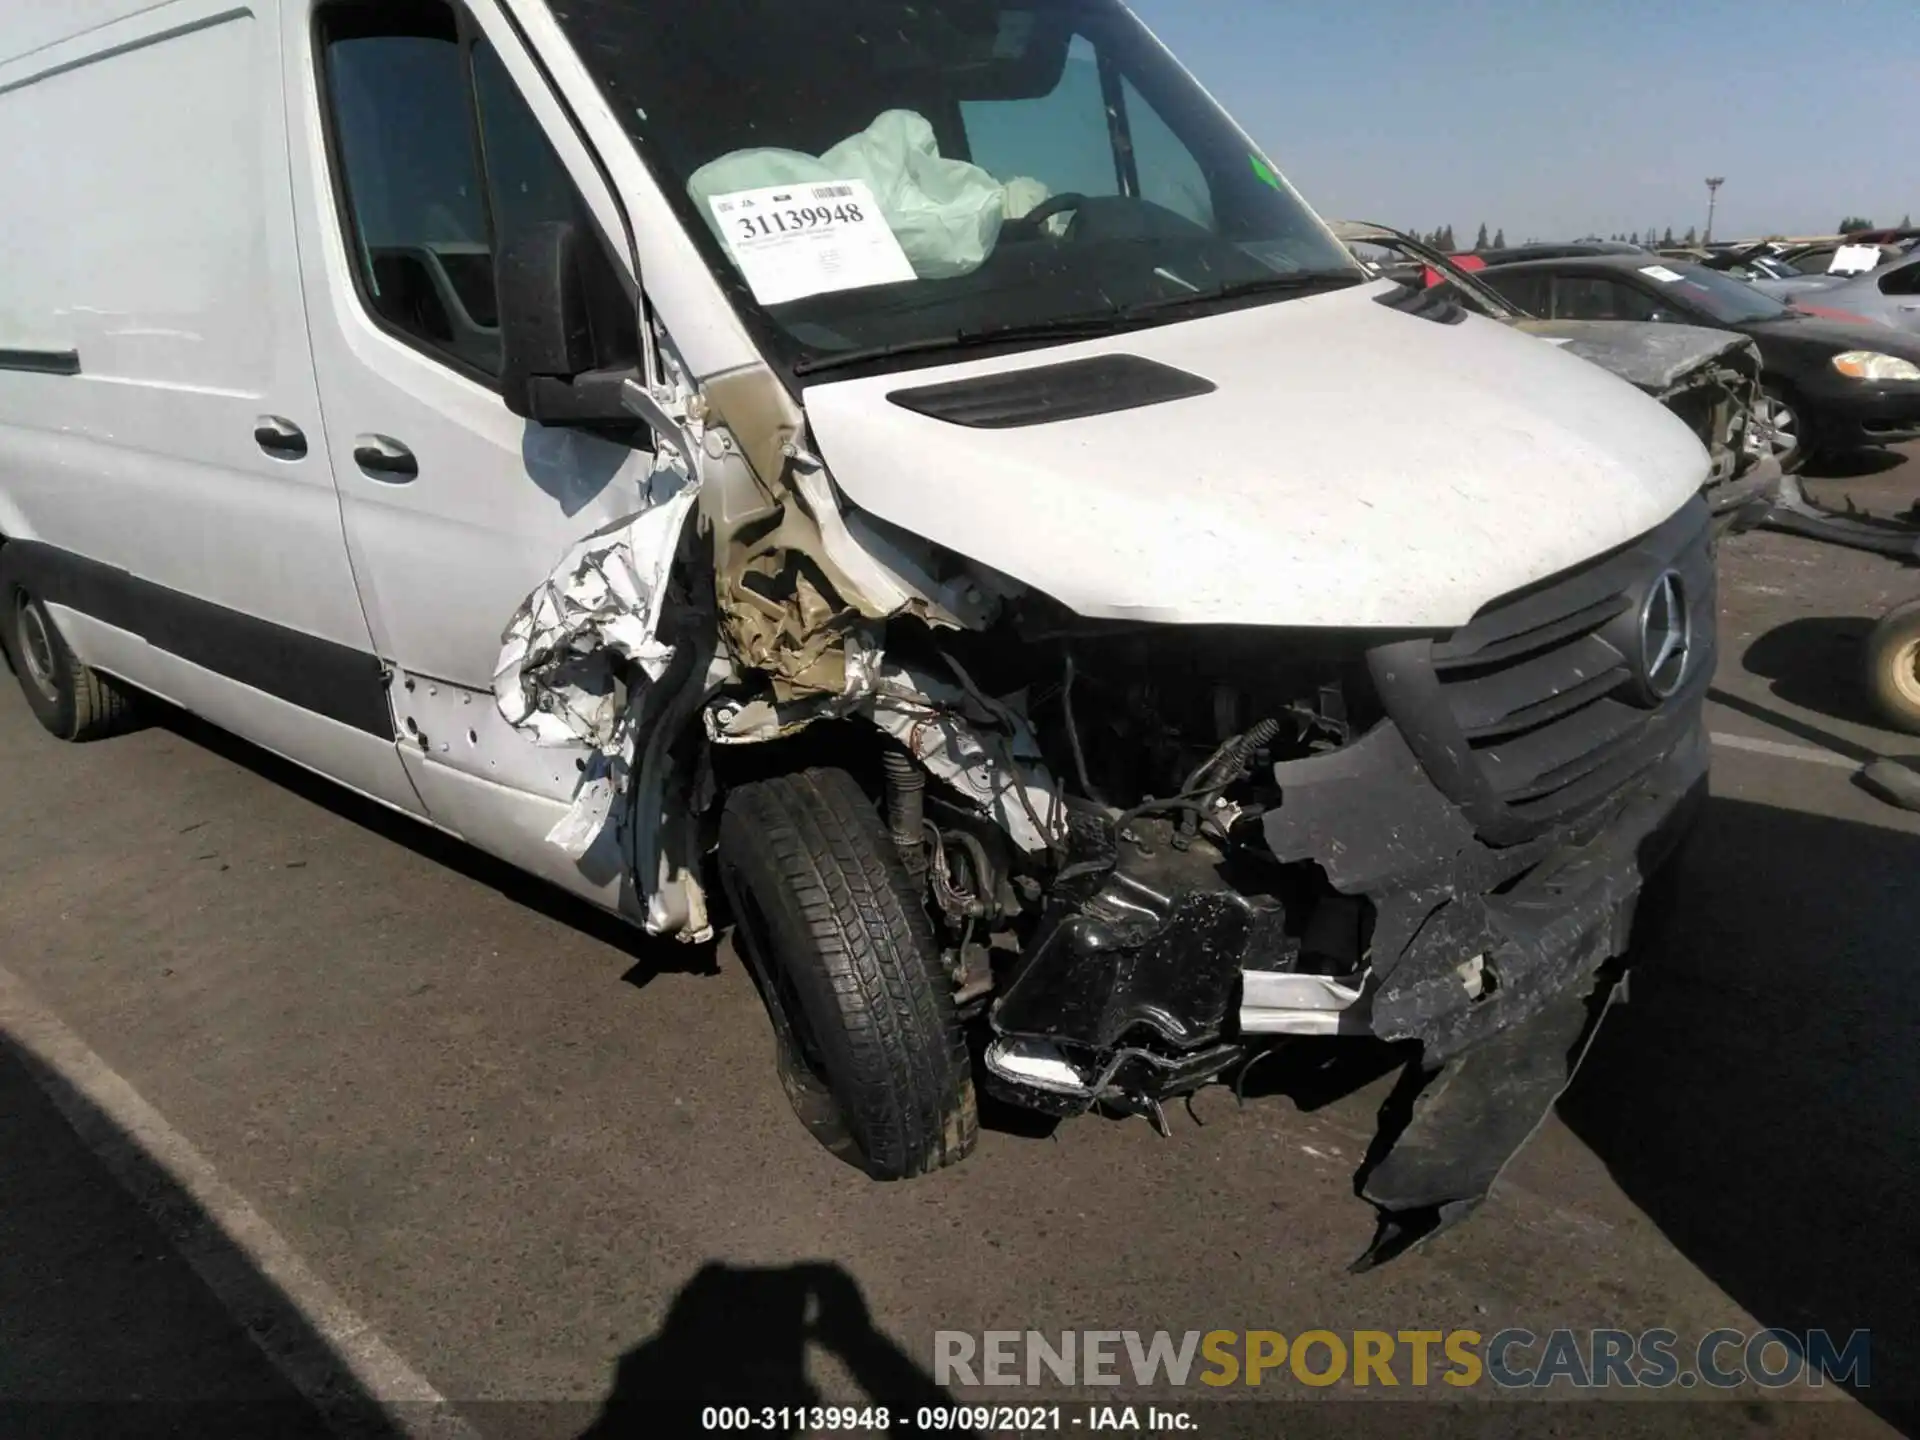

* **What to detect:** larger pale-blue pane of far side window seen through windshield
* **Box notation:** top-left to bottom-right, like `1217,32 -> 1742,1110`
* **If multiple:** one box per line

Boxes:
960,35 -> 1119,196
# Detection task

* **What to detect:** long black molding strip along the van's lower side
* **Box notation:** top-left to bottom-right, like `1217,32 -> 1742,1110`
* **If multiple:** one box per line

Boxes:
0,540 -> 396,741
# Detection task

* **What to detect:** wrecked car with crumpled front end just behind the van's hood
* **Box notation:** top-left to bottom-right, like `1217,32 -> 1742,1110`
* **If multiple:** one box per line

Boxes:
1332,221 -> 1776,515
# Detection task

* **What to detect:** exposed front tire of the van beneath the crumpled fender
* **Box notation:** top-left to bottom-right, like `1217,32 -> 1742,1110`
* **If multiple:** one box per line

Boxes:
720,770 -> 979,1181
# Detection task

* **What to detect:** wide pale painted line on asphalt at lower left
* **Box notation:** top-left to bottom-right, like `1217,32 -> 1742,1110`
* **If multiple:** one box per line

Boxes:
0,966 -> 478,1440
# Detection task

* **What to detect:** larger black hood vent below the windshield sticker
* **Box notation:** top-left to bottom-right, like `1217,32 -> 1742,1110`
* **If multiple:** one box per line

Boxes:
887,355 -> 1219,430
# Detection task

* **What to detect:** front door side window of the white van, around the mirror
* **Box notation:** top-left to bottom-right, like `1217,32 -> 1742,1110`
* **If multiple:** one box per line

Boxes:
321,0 -> 639,382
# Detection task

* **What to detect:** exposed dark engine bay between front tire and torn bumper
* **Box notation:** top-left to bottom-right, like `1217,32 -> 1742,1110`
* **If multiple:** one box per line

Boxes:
871,614 -> 1379,1090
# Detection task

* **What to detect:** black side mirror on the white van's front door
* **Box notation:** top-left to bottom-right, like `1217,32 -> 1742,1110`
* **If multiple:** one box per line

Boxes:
493,221 -> 634,424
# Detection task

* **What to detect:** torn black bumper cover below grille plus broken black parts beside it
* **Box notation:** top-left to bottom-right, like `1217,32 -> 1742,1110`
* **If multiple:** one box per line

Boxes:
987,721 -> 1709,1269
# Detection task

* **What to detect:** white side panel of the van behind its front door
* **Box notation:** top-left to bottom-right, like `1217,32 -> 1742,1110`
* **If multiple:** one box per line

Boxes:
0,0 -> 420,812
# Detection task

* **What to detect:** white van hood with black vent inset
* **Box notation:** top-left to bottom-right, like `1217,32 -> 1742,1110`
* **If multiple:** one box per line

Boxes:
803,284 -> 1709,630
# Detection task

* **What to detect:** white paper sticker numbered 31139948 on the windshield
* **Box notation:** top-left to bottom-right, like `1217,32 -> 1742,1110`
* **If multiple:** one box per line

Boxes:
707,180 -> 916,305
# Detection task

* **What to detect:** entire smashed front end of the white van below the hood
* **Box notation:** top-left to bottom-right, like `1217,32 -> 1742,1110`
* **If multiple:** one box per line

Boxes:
497,347 -> 1715,1265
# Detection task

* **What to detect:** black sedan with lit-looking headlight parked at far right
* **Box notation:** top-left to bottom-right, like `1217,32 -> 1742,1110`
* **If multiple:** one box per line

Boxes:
1480,255 -> 1920,470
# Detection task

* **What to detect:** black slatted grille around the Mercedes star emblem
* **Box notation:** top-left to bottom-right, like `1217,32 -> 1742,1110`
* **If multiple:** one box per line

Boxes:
1371,499 -> 1716,845
